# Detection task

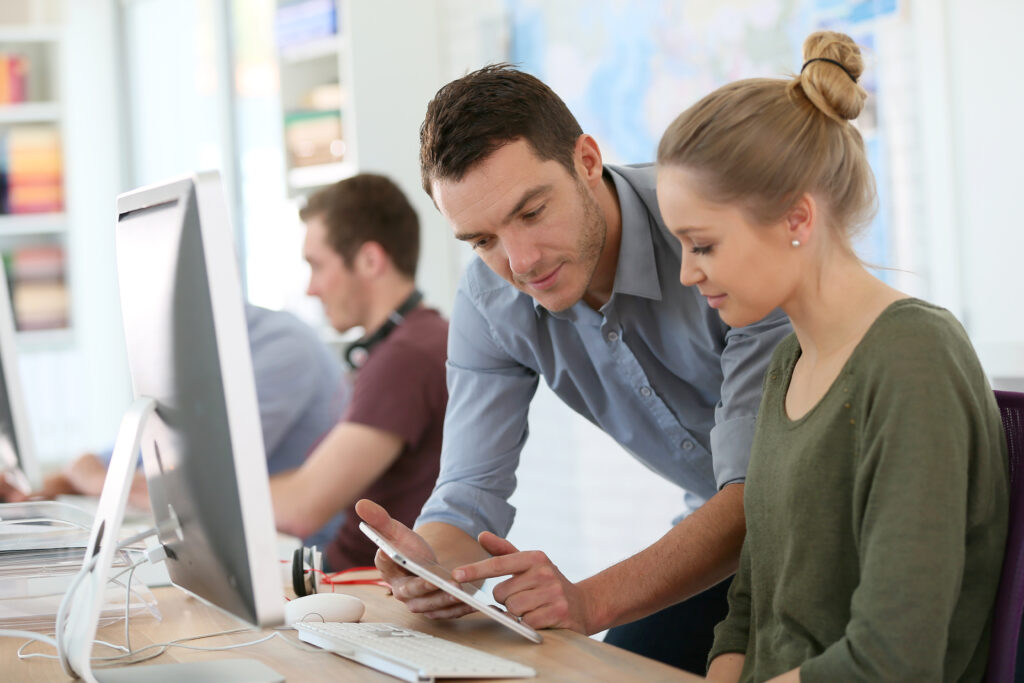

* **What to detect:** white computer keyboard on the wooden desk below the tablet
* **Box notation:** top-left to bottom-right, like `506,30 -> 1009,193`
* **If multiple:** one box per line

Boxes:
293,622 -> 537,682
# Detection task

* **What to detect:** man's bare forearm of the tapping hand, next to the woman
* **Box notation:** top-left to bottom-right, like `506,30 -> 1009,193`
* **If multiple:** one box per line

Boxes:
579,484 -> 746,633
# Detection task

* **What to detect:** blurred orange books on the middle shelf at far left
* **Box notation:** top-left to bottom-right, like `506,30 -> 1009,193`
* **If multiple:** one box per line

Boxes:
0,125 -> 63,214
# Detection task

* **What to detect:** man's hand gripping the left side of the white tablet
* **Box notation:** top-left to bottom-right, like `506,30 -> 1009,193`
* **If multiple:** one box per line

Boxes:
355,499 -> 474,618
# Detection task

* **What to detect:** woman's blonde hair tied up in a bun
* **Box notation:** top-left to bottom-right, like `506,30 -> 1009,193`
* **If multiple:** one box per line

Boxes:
657,31 -> 877,251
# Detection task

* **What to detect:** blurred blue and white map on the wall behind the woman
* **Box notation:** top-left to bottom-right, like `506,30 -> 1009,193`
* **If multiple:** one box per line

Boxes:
508,0 -> 900,278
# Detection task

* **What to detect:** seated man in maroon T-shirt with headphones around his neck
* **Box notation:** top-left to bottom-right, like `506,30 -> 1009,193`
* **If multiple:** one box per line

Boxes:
270,174 -> 447,571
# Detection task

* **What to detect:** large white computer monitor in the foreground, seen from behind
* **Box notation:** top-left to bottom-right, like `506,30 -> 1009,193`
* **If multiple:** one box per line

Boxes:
62,173 -> 285,680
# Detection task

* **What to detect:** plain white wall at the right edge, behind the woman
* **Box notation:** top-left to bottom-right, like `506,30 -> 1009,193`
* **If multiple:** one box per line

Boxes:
937,0 -> 1024,380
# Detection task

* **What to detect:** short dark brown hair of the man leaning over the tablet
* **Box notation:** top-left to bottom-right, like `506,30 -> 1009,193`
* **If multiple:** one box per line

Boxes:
420,63 -> 583,195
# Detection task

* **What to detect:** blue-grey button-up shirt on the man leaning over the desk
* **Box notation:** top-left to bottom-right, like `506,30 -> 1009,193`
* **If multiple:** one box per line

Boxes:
417,165 -> 792,538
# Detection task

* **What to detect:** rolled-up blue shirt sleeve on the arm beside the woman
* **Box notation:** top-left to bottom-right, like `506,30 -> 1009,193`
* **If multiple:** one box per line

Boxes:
711,309 -> 793,489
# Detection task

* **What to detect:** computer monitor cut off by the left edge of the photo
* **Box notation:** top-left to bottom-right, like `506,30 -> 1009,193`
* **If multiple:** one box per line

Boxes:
0,264 -> 41,494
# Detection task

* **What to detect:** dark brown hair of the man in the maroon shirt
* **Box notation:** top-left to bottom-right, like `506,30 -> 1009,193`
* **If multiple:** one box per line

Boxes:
299,173 -> 420,280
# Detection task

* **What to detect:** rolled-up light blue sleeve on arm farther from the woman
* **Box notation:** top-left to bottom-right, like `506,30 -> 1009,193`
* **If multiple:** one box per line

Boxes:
416,289 -> 538,538
